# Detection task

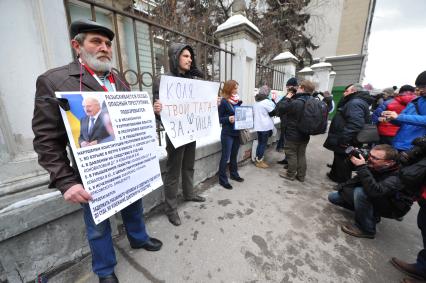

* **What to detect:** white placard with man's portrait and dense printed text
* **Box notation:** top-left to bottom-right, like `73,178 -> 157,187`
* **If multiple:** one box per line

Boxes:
56,92 -> 163,224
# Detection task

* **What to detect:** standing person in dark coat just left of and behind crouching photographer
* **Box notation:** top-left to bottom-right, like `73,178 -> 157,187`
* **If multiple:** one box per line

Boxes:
324,84 -> 374,183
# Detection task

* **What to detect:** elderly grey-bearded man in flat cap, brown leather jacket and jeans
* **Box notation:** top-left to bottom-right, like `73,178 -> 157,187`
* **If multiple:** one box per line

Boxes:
32,20 -> 162,283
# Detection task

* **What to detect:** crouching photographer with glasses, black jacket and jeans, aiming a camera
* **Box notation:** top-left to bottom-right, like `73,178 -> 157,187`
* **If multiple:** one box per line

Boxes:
328,144 -> 413,239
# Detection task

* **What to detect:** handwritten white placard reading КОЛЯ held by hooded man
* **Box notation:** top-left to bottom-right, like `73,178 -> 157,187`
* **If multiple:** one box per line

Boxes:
160,76 -> 219,147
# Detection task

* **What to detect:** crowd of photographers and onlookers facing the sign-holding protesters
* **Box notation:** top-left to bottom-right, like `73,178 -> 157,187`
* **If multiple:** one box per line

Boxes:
223,74 -> 426,283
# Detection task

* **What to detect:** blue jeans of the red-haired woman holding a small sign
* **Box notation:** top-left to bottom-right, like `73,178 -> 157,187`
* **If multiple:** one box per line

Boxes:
219,134 -> 240,185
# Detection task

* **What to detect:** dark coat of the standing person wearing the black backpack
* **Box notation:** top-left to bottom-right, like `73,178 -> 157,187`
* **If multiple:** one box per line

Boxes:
278,93 -> 310,142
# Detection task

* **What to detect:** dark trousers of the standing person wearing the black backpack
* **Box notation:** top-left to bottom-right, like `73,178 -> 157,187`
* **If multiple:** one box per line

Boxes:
284,140 -> 308,178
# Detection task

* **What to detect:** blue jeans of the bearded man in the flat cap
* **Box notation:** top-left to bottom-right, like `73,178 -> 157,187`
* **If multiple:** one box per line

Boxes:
81,199 -> 149,277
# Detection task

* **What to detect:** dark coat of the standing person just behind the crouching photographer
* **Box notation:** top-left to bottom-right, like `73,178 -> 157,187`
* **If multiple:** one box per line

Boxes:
324,91 -> 374,153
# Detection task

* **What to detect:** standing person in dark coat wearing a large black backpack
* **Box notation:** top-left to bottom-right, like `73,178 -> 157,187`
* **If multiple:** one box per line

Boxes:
278,80 -> 315,182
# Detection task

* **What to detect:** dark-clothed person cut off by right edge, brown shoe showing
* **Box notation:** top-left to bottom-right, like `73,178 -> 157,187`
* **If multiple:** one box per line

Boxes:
391,136 -> 426,283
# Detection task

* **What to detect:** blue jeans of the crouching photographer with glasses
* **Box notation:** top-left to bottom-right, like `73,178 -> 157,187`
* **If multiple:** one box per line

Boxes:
328,187 -> 376,235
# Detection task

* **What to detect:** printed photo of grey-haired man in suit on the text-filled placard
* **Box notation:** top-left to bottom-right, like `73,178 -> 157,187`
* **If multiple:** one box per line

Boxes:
62,94 -> 115,148
